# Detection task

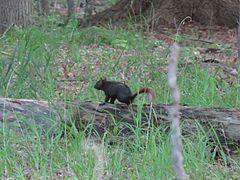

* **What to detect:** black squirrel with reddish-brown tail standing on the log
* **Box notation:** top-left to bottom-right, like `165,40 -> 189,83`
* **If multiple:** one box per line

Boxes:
94,78 -> 155,105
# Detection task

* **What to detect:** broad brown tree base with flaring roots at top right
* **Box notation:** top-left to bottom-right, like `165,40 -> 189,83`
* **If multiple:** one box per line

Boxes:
84,0 -> 240,28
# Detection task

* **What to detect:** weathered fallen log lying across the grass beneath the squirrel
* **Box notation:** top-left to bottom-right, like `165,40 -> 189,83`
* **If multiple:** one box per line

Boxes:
0,98 -> 240,145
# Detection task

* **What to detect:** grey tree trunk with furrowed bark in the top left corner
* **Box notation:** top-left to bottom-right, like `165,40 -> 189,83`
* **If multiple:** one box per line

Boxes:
0,0 -> 32,33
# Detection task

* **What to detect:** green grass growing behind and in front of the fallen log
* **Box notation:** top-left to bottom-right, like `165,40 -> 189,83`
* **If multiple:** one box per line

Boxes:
0,16 -> 240,179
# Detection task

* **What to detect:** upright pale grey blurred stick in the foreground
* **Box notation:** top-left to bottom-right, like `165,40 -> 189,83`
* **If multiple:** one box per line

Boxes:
168,42 -> 188,180
